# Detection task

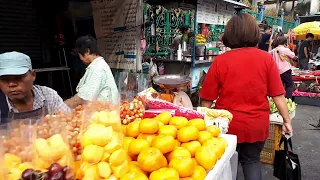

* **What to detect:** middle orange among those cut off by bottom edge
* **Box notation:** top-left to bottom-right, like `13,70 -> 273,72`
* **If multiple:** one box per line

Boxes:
149,167 -> 179,180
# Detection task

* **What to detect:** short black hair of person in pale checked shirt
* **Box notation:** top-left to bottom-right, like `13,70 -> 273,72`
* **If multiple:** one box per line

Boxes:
75,35 -> 100,55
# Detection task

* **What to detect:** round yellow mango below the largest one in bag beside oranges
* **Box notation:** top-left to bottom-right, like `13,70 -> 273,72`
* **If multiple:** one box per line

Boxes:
82,145 -> 103,164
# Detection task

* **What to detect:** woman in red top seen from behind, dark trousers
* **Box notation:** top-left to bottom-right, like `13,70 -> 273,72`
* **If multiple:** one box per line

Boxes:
200,13 -> 292,180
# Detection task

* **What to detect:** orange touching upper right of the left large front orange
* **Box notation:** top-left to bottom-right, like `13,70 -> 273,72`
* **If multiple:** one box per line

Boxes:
151,135 -> 176,154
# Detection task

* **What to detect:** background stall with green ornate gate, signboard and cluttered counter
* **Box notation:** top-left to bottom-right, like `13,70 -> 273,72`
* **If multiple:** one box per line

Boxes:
144,0 -> 247,105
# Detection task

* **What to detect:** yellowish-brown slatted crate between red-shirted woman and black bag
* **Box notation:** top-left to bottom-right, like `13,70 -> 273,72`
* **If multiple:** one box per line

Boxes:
260,123 -> 283,165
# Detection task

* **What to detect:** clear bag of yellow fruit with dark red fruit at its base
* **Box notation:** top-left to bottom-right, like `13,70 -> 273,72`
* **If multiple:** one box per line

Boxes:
32,118 -> 75,180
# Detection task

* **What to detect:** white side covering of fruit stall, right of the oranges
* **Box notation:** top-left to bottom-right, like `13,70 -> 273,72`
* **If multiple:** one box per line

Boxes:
205,134 -> 238,180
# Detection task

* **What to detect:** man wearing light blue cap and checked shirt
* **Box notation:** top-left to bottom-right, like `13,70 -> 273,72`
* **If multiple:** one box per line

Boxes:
0,52 -> 71,123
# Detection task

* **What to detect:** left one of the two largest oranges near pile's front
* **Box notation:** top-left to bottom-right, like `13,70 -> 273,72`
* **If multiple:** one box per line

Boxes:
137,147 -> 168,173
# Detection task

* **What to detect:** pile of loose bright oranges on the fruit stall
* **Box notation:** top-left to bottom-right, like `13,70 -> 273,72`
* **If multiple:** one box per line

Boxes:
121,112 -> 227,180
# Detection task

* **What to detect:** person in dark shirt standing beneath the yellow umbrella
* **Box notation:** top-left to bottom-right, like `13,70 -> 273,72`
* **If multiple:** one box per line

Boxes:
299,33 -> 314,70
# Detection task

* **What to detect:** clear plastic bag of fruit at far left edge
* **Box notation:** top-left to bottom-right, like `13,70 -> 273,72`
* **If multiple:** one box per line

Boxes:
1,118 -> 37,180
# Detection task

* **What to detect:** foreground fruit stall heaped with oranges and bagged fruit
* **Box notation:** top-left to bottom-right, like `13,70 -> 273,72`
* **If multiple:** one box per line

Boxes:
0,91 -> 237,180
